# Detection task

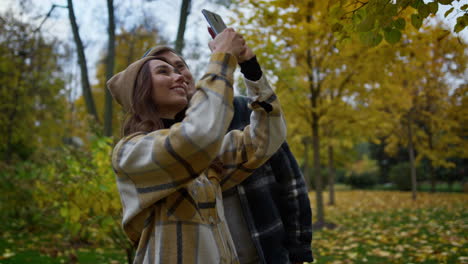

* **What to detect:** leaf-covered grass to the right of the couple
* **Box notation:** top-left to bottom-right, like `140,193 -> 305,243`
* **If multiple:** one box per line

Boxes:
309,191 -> 468,264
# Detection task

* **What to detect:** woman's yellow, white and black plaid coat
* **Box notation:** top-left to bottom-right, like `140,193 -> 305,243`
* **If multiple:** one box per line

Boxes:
112,53 -> 286,264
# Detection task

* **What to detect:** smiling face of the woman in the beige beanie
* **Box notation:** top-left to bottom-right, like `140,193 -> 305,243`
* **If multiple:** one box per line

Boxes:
148,60 -> 188,118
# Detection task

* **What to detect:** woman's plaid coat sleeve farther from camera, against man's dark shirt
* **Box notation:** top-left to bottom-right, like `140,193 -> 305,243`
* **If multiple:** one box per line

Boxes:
219,76 -> 286,191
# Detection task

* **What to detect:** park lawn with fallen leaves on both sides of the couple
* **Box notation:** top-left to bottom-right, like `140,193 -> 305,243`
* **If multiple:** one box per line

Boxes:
0,191 -> 468,264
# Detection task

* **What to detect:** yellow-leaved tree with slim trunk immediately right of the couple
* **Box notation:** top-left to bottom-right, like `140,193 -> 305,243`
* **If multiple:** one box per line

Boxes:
232,0 -> 391,228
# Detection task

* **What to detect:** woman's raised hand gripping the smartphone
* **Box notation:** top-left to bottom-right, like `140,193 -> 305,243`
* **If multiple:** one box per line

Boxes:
208,28 -> 246,57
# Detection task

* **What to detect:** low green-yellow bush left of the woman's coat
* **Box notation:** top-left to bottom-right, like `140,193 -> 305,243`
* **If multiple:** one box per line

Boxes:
0,138 -> 132,262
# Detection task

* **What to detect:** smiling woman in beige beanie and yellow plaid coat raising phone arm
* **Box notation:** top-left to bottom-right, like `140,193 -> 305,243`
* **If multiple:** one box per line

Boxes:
108,29 -> 286,264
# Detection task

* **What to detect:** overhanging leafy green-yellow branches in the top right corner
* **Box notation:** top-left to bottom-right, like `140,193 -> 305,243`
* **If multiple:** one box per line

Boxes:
329,0 -> 468,46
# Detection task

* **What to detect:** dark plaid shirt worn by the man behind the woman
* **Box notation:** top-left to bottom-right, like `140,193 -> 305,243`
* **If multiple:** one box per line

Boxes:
223,96 -> 313,264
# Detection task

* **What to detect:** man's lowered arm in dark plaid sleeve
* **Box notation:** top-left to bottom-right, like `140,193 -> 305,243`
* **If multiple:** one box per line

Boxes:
270,142 -> 313,263
